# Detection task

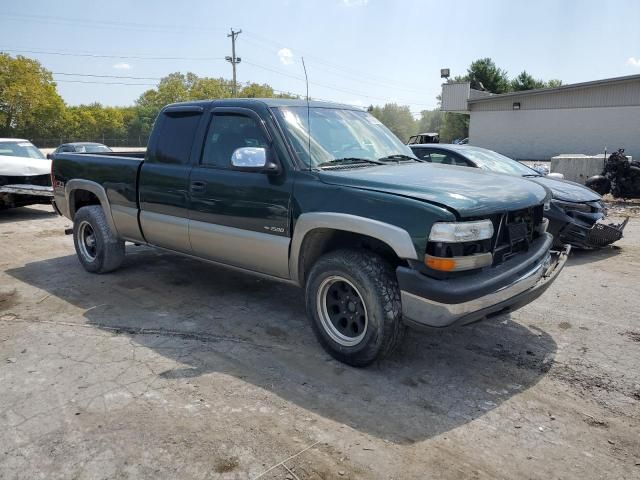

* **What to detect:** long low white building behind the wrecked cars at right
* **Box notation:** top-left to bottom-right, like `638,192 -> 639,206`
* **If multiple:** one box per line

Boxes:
442,75 -> 640,160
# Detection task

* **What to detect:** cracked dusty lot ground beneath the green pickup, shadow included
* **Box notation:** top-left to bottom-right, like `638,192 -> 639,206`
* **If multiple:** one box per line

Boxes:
0,206 -> 640,480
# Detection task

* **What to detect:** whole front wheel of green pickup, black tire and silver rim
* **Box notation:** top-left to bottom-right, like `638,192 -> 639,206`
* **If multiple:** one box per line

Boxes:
305,250 -> 405,367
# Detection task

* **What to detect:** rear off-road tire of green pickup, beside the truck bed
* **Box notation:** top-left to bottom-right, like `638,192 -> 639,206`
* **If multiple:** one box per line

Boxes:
73,205 -> 125,273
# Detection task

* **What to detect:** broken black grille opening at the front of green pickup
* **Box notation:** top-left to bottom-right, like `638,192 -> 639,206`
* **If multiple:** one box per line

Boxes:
491,205 -> 543,265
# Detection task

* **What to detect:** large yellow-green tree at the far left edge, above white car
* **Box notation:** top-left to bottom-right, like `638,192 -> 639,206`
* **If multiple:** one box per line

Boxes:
0,53 -> 64,138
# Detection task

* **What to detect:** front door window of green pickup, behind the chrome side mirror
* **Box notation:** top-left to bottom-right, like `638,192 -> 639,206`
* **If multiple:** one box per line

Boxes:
202,113 -> 268,168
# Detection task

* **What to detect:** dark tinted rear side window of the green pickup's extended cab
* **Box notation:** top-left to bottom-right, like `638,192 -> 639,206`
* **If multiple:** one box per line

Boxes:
155,113 -> 201,165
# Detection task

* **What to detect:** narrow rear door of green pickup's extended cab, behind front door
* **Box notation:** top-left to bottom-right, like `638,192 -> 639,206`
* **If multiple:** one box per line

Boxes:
139,105 -> 203,253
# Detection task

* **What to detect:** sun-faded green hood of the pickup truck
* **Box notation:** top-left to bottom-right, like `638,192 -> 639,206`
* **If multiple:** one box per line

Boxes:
319,163 -> 547,217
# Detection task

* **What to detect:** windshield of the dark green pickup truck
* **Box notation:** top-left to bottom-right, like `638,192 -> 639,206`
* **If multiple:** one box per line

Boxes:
274,107 -> 415,168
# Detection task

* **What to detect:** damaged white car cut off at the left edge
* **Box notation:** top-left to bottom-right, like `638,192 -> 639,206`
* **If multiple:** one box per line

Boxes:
0,138 -> 53,210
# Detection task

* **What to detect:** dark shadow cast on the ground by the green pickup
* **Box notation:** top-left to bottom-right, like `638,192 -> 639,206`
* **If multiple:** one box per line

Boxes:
7,246 -> 556,444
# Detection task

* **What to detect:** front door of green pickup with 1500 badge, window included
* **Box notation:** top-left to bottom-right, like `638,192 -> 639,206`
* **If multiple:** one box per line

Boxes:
189,107 -> 293,278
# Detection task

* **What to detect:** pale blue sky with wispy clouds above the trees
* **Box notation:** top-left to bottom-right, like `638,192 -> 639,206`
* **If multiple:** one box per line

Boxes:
0,0 -> 640,114
